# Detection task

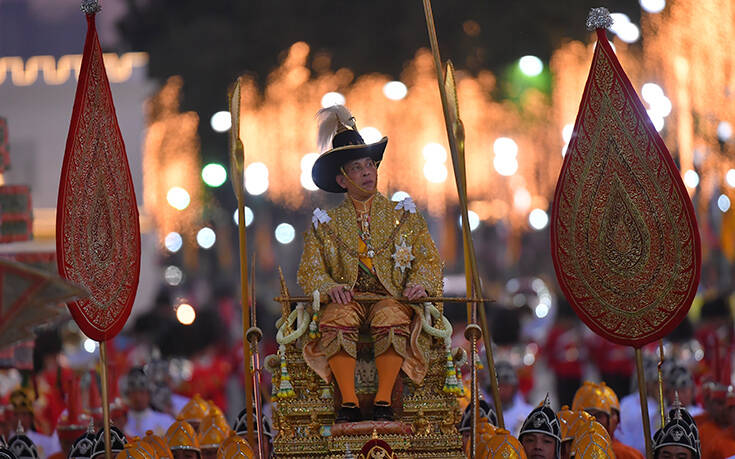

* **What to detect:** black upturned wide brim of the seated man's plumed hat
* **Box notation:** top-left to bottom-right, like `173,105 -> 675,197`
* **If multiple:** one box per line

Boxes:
311,137 -> 388,193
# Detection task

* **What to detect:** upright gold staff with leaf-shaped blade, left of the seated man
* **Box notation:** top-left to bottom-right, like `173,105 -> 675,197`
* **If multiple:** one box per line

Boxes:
229,78 -> 261,449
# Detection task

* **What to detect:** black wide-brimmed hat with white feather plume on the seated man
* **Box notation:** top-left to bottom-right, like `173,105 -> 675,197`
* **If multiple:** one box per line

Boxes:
311,105 -> 388,193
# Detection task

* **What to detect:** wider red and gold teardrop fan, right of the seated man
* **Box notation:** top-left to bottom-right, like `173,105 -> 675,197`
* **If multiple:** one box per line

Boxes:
551,10 -> 701,348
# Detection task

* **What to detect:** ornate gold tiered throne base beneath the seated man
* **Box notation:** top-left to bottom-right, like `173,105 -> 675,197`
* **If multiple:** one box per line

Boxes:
266,328 -> 465,459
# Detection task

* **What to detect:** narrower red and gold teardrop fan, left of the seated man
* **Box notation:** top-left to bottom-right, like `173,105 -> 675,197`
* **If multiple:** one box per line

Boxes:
56,1 -> 140,341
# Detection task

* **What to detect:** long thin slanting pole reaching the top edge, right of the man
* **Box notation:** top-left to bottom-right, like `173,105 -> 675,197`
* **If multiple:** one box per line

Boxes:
423,0 -> 505,434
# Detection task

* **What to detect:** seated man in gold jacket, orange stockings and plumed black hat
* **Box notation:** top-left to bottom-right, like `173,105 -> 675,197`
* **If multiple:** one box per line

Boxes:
298,106 -> 443,422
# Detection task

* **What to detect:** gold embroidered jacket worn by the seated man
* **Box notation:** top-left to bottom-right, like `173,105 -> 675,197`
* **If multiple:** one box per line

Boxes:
297,193 -> 443,298
